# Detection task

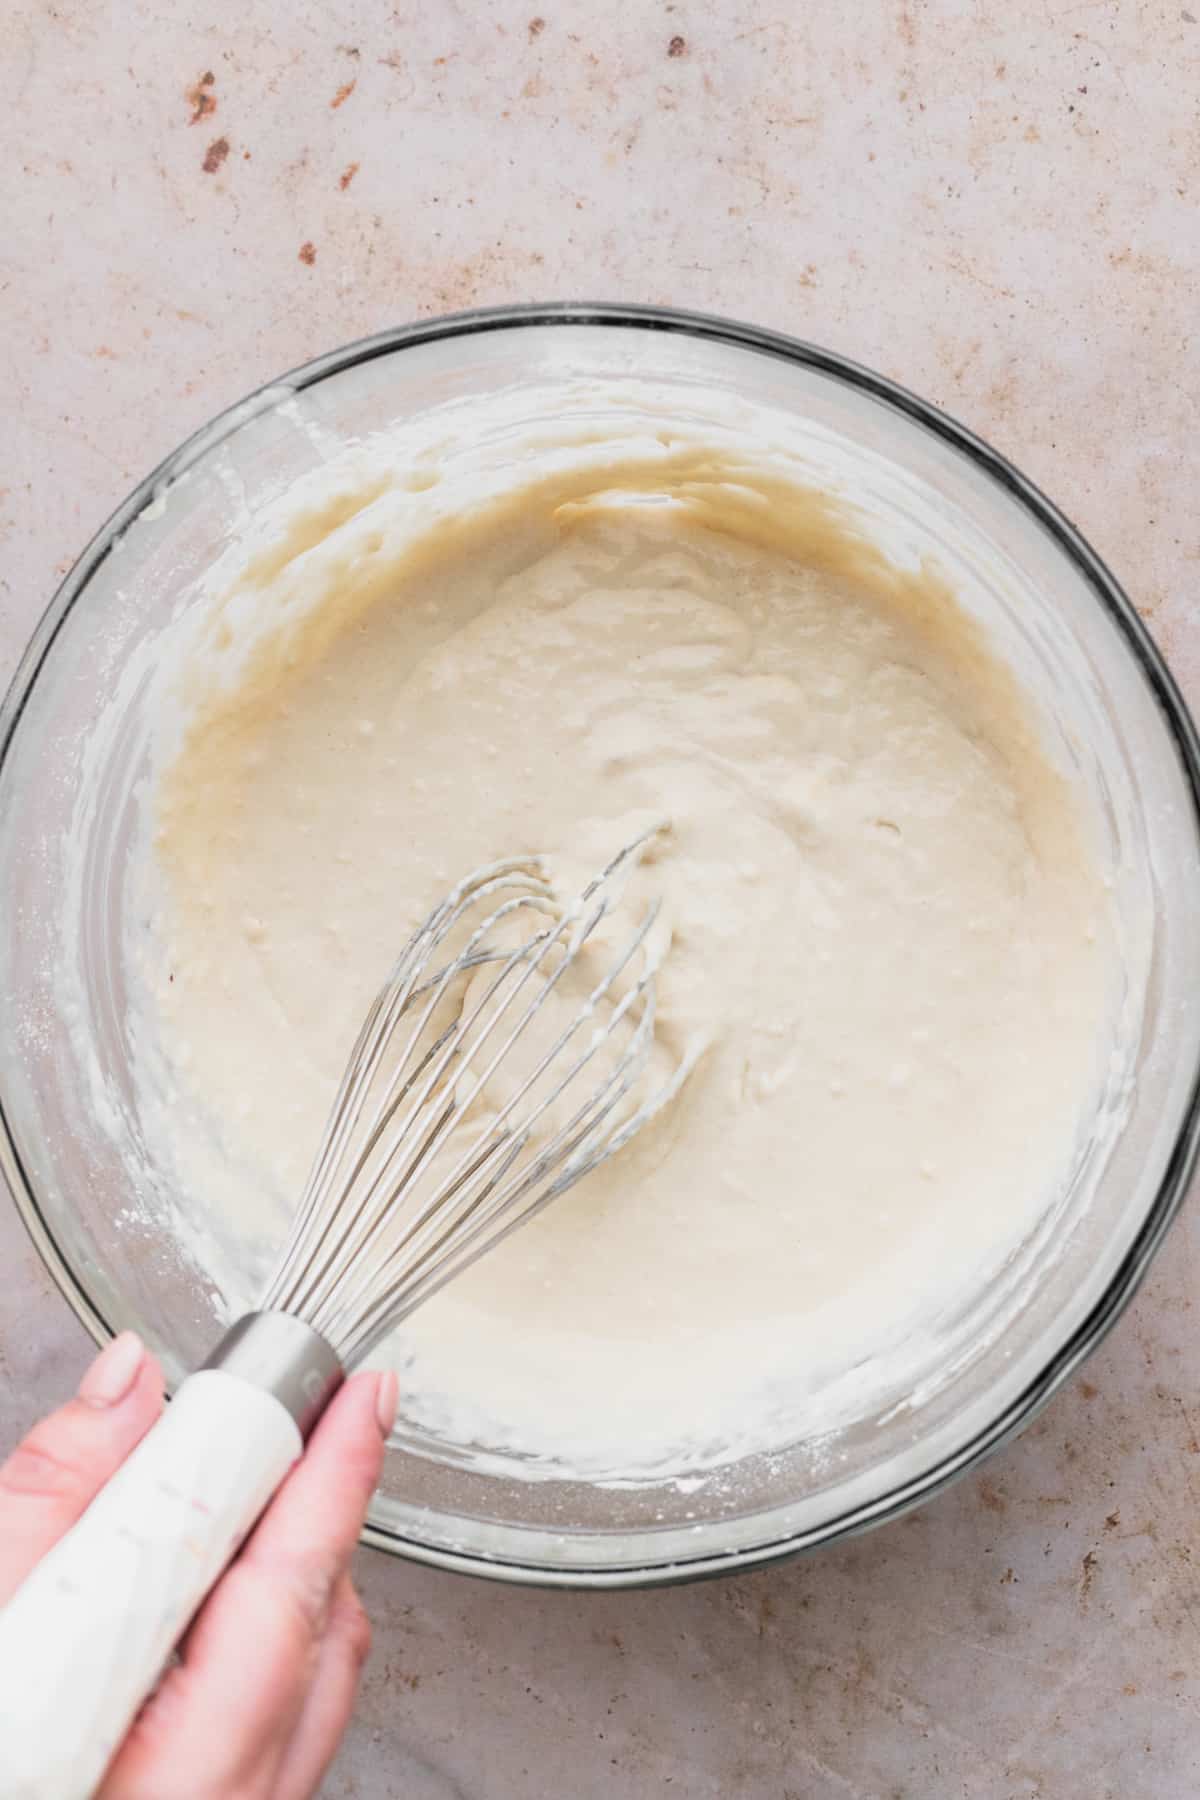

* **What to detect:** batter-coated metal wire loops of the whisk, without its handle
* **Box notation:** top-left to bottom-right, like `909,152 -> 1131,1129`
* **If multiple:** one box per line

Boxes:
261,830 -> 696,1364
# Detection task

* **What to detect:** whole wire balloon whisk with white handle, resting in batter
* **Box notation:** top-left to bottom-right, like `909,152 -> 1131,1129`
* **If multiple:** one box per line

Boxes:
0,832 -> 696,1800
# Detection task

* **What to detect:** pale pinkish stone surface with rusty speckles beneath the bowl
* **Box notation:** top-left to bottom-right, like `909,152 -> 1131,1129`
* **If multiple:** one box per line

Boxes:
0,0 -> 1200,1800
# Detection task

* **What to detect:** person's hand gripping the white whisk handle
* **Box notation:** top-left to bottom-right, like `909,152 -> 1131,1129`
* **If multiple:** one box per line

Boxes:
0,1332 -> 396,1800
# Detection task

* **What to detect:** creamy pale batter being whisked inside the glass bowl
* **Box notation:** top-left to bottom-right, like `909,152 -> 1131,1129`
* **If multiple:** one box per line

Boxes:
134,390 -> 1114,1476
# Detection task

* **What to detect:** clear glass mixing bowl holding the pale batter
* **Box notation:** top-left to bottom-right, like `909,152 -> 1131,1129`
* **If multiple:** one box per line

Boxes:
0,306 -> 1200,1586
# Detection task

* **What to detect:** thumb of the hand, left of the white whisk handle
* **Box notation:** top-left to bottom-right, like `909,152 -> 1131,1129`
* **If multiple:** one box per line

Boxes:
0,1332 -> 162,1606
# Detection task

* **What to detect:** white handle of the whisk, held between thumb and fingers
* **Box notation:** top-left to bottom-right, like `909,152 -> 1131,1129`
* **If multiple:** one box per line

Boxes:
0,1368 -> 302,1800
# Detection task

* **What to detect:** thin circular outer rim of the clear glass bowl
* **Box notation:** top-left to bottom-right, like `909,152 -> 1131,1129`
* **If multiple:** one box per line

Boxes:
0,301 -> 1200,1589
